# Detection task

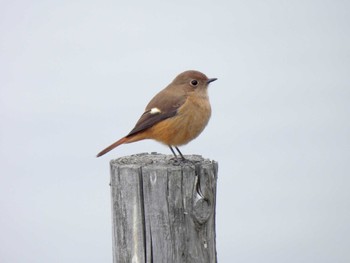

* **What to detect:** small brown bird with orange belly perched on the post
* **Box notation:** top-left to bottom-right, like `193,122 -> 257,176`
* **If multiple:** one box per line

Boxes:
97,70 -> 217,160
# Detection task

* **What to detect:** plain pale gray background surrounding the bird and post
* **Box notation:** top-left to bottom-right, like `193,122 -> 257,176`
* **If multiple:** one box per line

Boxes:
0,0 -> 350,263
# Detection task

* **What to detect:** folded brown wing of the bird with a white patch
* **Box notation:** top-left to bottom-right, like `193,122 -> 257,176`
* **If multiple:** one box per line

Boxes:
126,89 -> 186,137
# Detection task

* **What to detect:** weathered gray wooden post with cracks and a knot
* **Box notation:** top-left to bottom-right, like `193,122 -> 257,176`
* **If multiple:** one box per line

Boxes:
110,153 -> 218,263
